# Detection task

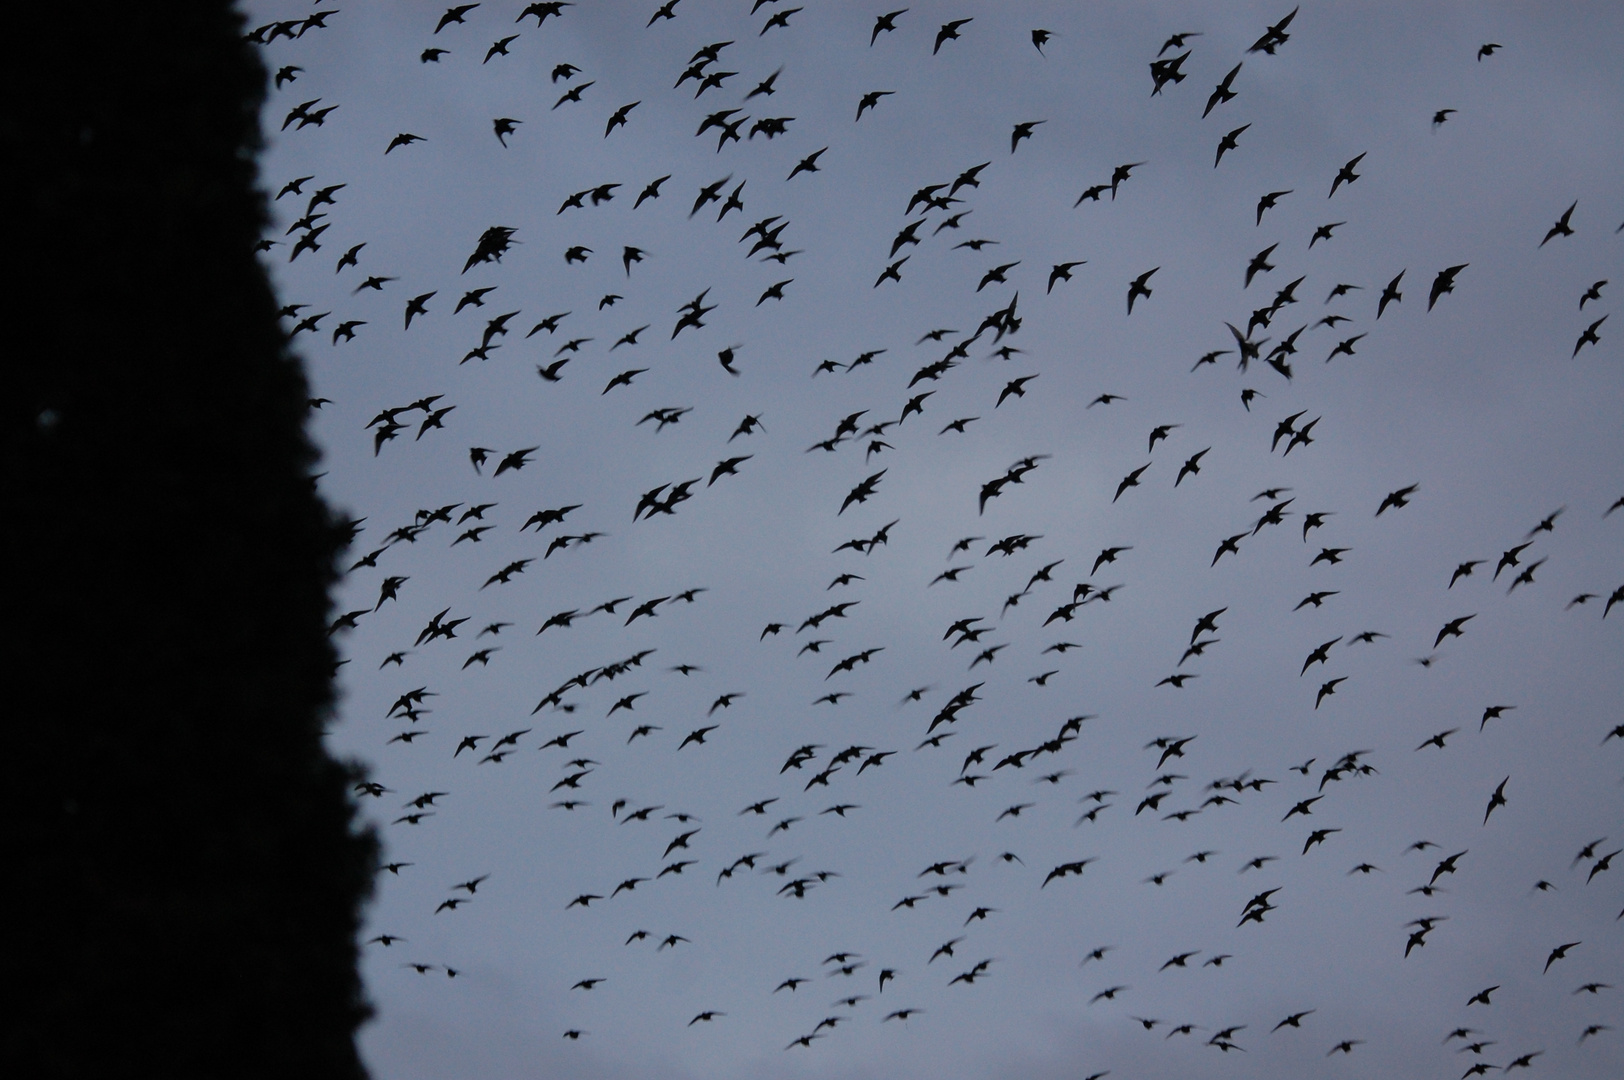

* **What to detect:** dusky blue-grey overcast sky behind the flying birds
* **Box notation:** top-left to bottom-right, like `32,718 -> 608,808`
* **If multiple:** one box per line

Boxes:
247,0 -> 1624,1080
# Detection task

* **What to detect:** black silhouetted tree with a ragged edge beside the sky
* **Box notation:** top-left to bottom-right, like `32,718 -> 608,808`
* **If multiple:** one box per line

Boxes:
0,0 -> 377,1078
